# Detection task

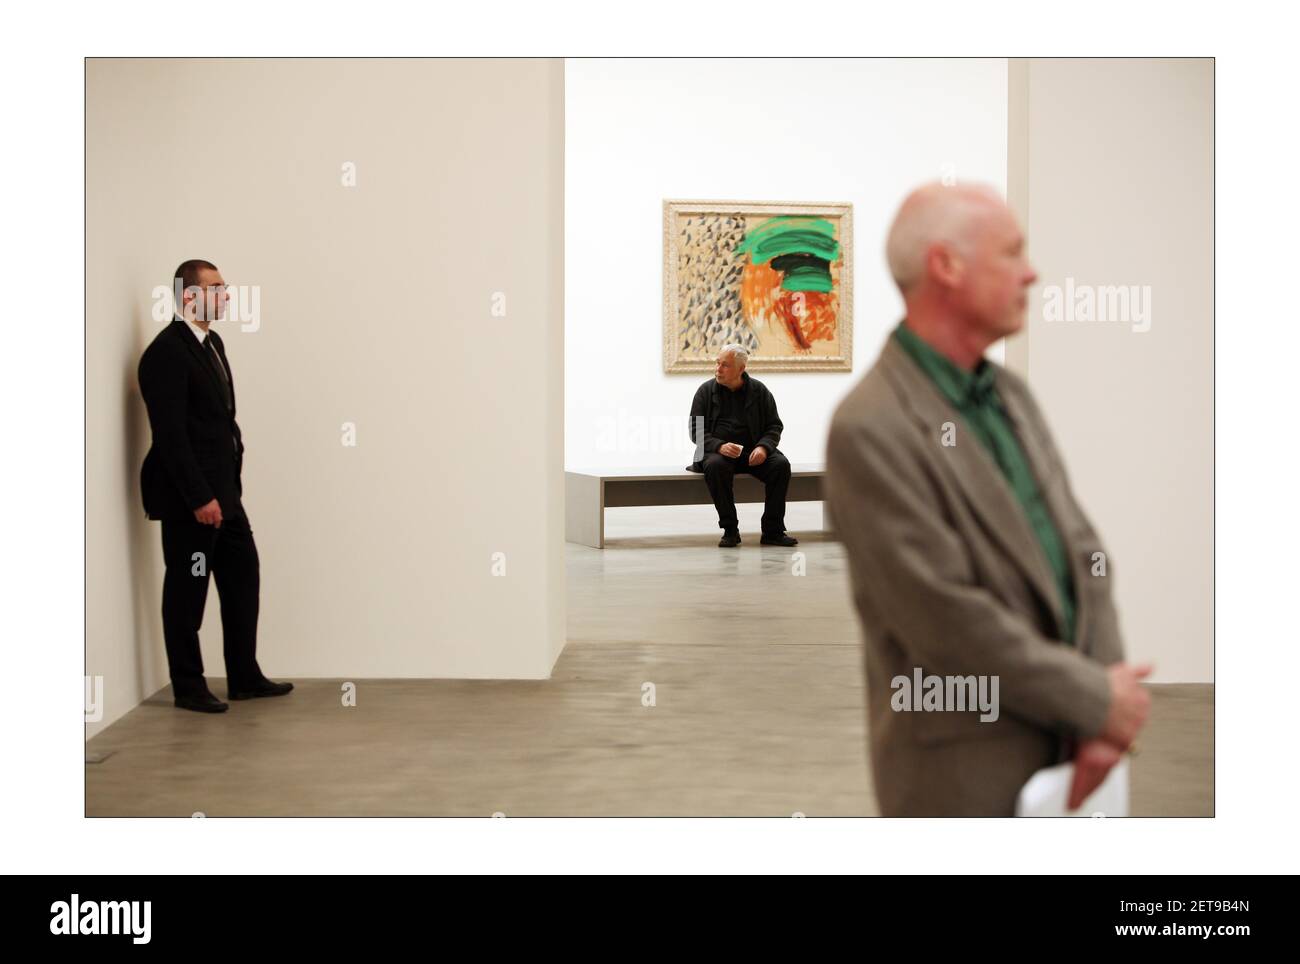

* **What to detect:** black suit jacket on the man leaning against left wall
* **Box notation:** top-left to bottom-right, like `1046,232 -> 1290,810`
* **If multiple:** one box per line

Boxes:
138,318 -> 243,520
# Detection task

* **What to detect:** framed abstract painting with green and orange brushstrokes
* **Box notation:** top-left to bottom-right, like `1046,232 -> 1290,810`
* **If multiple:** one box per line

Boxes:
663,200 -> 853,374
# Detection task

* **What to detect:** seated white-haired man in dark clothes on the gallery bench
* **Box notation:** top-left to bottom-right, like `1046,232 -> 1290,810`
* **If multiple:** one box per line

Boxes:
690,344 -> 798,548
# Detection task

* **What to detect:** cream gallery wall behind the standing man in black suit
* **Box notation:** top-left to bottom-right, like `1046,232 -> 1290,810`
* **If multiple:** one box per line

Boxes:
86,60 -> 564,735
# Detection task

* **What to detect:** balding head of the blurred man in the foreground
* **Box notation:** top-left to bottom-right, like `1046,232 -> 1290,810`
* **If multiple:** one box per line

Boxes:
885,182 -> 1037,356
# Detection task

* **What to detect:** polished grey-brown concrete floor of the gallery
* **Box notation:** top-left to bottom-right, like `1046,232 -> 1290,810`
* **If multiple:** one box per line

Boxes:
86,503 -> 1213,817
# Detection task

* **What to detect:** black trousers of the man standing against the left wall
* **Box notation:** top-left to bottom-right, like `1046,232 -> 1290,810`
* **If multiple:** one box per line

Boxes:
163,513 -> 263,696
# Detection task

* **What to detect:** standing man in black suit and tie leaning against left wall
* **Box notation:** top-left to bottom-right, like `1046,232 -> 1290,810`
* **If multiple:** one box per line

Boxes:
139,261 -> 294,713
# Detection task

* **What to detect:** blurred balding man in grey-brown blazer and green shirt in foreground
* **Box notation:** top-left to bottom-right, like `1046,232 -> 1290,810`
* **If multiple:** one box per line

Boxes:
826,184 -> 1151,816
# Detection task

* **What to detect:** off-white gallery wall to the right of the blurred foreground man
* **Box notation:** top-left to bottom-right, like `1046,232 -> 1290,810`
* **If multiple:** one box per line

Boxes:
1011,58 -> 1214,682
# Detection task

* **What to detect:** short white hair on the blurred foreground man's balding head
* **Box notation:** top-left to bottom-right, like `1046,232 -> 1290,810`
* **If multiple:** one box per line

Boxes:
885,182 -> 1004,291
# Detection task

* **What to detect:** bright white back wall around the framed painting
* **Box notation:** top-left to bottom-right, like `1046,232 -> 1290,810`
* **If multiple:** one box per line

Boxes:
564,60 -> 1008,468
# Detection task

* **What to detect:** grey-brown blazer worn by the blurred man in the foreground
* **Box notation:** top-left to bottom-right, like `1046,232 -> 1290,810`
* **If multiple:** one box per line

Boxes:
824,338 -> 1123,816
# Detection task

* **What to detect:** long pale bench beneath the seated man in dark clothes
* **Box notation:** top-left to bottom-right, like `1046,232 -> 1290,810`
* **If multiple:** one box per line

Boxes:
564,463 -> 831,550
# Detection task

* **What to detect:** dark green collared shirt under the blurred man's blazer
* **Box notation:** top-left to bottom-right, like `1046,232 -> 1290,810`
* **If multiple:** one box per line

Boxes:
893,322 -> 1075,643
